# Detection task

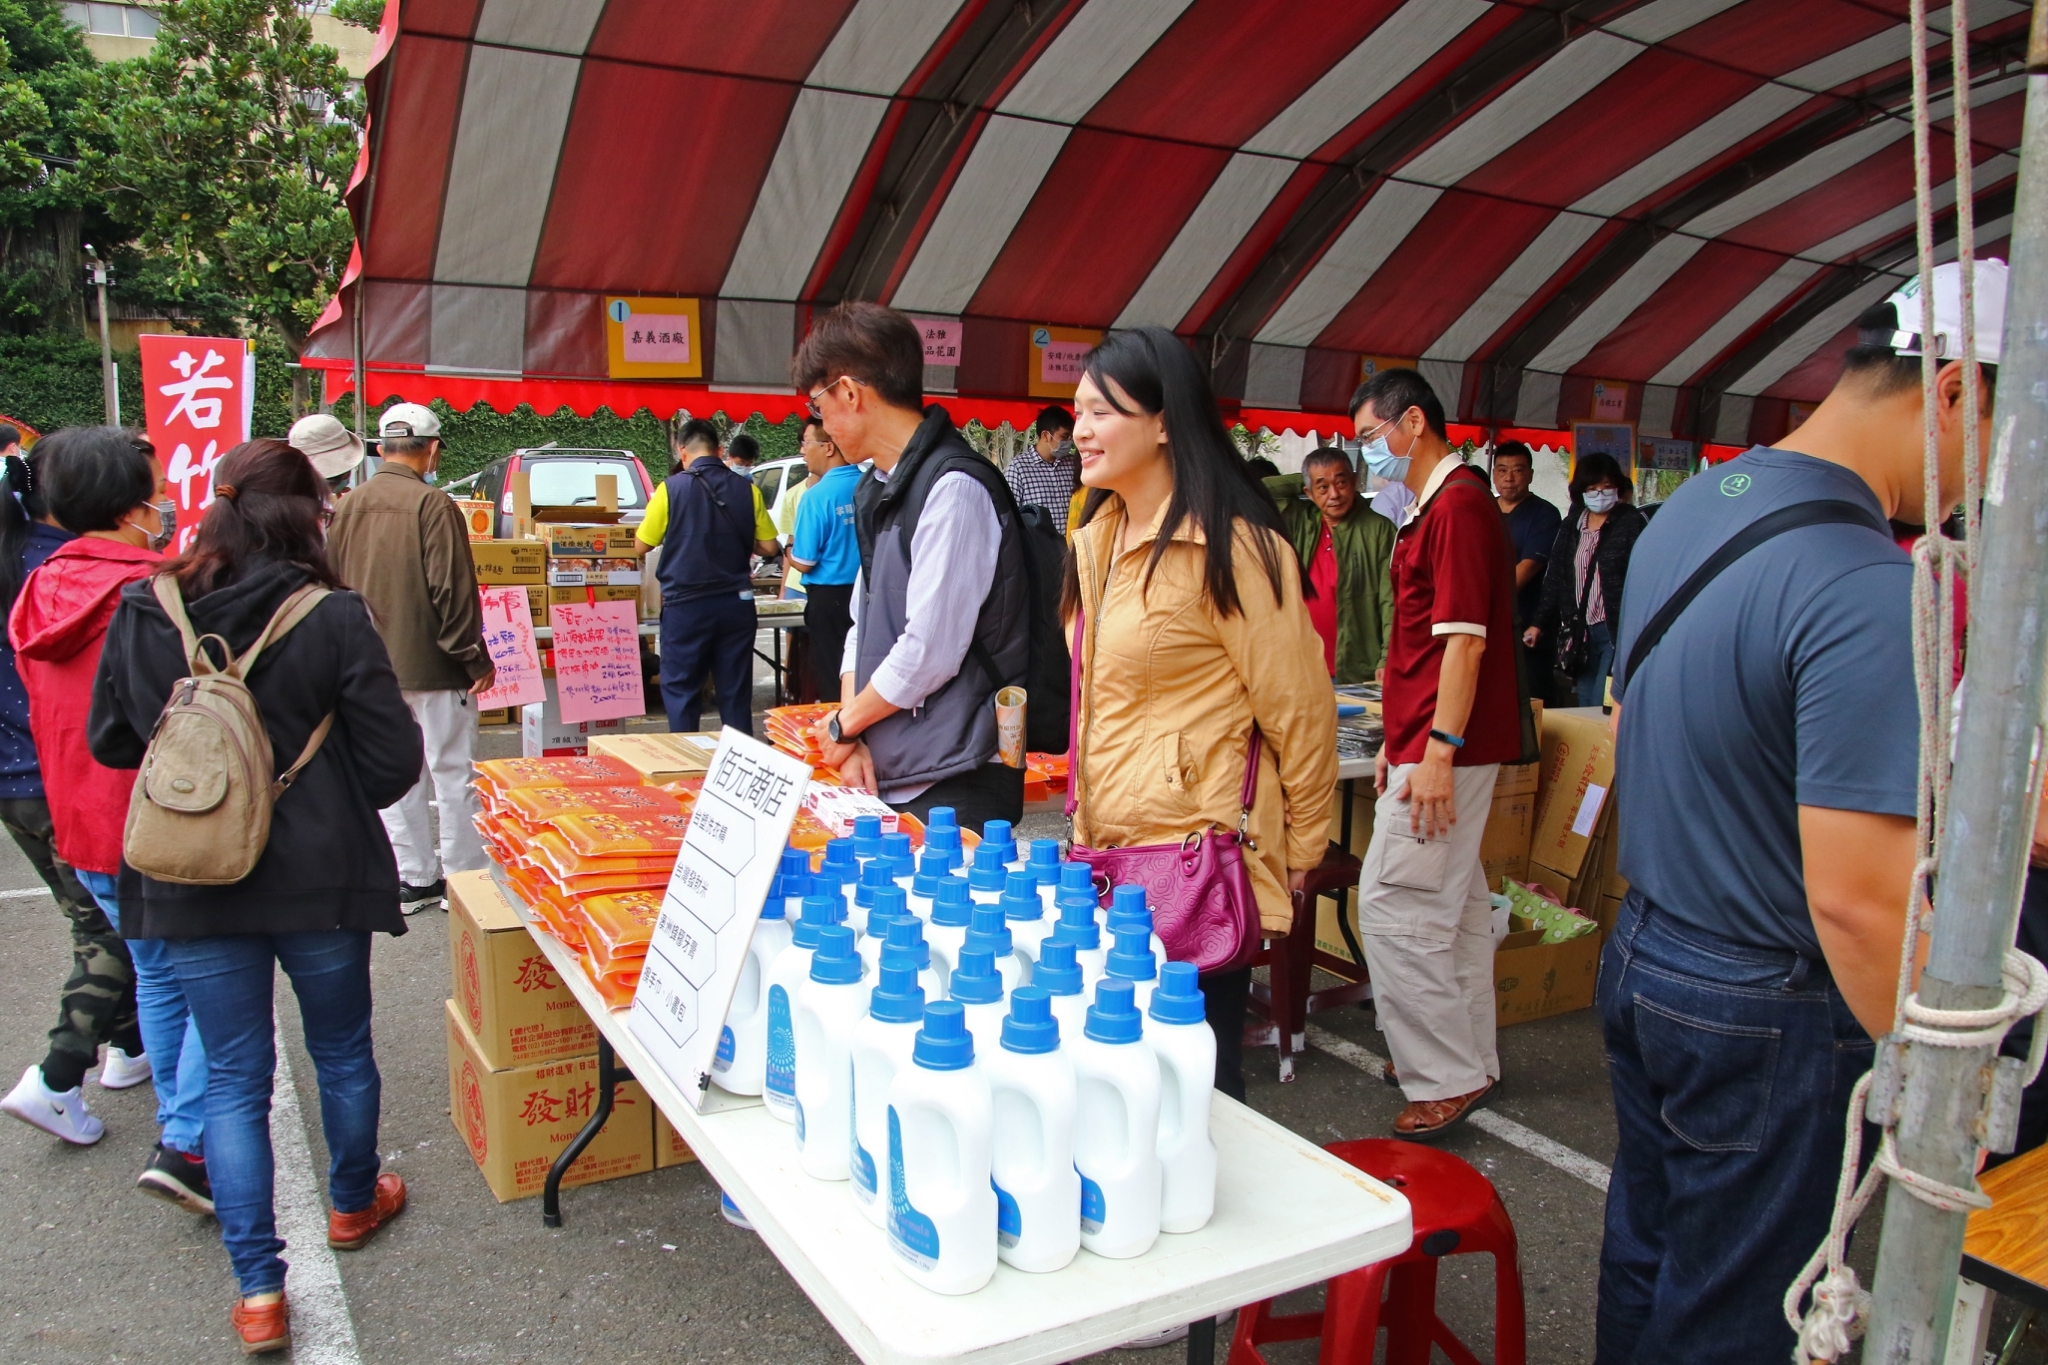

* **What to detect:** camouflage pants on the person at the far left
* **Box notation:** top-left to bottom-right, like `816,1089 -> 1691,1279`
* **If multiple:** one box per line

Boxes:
0,796 -> 141,1091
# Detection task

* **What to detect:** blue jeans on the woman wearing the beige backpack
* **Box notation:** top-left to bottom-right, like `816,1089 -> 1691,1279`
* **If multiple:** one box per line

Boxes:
164,929 -> 383,1293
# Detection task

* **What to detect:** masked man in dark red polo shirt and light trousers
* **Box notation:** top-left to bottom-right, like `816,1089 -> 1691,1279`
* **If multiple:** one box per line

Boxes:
1352,370 -> 1522,1142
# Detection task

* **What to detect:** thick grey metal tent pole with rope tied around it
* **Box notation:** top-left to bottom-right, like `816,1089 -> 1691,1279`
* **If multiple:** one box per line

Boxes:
1864,0 -> 2048,1365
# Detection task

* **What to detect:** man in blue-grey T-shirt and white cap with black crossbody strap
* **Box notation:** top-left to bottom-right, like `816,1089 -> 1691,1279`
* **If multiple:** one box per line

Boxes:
1595,262 -> 2005,1365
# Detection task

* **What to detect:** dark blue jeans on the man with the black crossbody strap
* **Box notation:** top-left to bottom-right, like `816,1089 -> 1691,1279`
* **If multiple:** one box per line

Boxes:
1593,892 -> 1874,1365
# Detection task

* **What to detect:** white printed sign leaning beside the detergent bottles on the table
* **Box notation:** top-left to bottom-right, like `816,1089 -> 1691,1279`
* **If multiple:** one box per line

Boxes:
627,731 -> 811,1109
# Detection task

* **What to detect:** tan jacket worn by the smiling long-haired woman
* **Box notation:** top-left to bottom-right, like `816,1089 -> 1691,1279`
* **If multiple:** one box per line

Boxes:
1067,497 -> 1337,933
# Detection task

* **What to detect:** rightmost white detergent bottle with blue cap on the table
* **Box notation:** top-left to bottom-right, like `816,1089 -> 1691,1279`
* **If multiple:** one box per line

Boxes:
1145,962 -> 1217,1232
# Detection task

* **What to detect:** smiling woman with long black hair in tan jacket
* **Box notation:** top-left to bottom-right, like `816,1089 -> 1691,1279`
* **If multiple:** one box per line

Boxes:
1063,327 -> 1337,1099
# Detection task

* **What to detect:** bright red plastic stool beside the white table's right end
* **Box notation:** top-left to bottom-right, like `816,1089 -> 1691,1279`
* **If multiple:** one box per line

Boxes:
1229,1138 -> 1528,1365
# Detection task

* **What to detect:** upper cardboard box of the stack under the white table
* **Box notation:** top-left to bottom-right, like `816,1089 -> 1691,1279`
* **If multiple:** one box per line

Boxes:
449,872 -> 598,1070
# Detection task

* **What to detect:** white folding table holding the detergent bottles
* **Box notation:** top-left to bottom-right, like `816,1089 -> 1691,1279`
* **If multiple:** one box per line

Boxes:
506,890 -> 1411,1365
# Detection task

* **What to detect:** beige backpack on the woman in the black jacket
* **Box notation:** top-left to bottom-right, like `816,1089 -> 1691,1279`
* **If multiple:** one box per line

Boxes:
121,573 -> 334,886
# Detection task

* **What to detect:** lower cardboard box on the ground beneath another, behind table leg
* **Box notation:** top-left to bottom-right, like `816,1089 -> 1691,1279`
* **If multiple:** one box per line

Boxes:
449,1001 -> 653,1203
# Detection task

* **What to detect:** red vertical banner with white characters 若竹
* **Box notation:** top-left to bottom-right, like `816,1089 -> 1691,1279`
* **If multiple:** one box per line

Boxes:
139,336 -> 256,553
